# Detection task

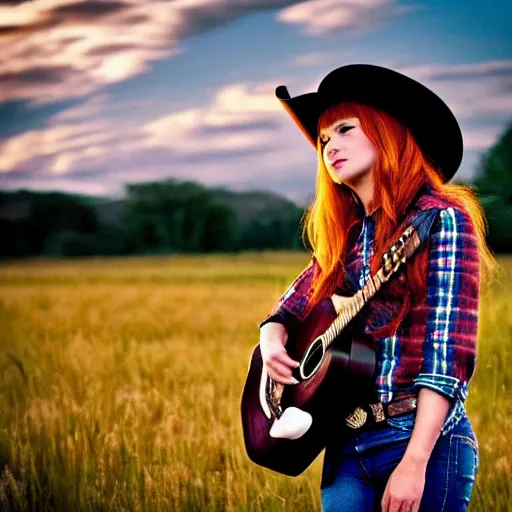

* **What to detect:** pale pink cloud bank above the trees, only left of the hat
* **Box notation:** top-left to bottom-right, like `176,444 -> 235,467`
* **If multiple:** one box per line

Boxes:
0,79 -> 316,199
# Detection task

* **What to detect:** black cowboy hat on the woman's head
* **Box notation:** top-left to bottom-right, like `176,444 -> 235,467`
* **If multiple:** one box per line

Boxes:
276,64 -> 463,181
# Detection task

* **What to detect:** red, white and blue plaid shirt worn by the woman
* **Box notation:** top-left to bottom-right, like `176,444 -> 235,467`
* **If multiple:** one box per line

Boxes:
260,193 -> 479,424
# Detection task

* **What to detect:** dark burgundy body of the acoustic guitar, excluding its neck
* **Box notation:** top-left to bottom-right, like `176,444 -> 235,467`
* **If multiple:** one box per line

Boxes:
241,299 -> 375,476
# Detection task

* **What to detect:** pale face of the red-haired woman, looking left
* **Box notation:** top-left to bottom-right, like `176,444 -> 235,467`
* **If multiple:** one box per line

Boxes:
319,117 -> 377,188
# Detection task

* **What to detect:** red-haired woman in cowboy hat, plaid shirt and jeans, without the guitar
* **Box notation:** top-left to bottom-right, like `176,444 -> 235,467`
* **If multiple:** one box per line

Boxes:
260,65 -> 492,512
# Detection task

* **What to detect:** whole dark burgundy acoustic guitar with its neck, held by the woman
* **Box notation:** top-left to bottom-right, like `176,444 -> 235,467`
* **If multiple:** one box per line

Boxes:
240,209 -> 437,476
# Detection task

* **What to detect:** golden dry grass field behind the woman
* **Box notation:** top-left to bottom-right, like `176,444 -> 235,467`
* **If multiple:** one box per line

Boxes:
0,253 -> 512,512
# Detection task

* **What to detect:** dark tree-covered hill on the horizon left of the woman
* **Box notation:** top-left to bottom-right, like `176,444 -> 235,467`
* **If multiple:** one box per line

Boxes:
0,183 -> 304,257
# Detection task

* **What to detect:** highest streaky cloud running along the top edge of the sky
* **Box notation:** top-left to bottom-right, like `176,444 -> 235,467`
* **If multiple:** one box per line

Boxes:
0,0 -> 408,104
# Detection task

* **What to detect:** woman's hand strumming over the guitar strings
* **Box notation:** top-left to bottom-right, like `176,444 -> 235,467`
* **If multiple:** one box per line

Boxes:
260,322 -> 299,384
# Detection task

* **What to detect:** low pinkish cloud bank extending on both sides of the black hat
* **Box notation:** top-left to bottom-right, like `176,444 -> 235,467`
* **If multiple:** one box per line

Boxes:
0,58 -> 512,201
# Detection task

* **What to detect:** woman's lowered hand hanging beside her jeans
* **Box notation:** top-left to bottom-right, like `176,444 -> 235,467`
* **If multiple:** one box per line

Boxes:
381,458 -> 427,512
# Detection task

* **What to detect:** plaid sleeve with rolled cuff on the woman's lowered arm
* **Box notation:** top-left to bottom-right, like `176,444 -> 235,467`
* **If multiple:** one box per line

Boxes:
415,208 -> 479,400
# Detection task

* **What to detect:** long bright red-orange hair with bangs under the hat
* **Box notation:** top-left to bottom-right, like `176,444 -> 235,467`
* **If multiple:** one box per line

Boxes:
303,103 -> 493,312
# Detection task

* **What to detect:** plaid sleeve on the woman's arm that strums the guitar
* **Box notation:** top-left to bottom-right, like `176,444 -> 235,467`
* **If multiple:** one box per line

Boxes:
259,257 -> 318,330
